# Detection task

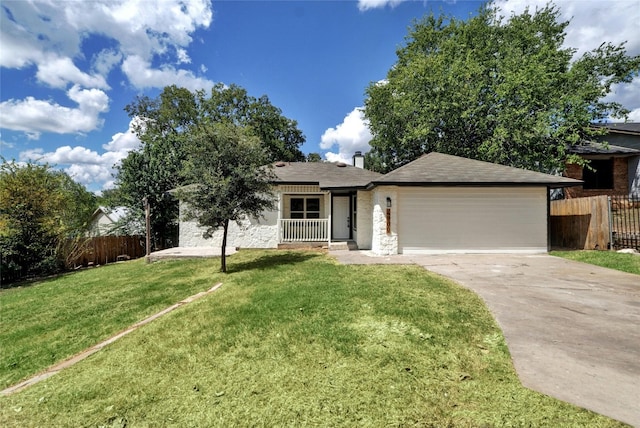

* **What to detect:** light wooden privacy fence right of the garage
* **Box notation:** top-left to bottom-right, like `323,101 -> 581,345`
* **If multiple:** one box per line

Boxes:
549,196 -> 611,250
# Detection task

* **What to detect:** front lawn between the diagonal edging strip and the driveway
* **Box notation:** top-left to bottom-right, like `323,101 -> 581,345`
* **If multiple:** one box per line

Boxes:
0,251 -> 621,427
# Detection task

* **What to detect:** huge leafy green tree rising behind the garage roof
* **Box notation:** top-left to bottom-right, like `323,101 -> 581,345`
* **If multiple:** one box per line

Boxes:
365,5 -> 640,172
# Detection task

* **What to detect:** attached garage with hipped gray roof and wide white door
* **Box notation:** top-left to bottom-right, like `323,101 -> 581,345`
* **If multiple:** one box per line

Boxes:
369,152 -> 581,254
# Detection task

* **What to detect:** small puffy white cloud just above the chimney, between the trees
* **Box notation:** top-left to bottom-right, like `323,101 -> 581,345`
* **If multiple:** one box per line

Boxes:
320,107 -> 371,163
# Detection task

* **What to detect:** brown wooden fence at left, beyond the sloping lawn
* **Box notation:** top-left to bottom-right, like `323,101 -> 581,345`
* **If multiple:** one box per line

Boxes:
66,236 -> 146,268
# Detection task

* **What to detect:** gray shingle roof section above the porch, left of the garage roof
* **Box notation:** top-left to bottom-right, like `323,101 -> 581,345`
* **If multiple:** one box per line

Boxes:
273,162 -> 381,189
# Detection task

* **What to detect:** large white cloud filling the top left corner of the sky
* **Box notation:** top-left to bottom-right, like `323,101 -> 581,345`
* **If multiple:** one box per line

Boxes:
0,0 -> 213,67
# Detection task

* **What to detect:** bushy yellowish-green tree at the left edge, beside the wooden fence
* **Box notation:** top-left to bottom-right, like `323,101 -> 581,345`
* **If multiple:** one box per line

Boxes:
0,162 -> 97,281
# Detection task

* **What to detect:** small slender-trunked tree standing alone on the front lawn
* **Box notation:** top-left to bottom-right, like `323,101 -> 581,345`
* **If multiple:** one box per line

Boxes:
177,122 -> 275,272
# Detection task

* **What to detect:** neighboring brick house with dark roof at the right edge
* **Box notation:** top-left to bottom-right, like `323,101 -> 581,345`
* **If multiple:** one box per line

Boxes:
565,123 -> 640,198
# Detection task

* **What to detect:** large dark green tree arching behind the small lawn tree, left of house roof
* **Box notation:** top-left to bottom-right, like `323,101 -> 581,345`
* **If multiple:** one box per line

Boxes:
116,84 -> 305,248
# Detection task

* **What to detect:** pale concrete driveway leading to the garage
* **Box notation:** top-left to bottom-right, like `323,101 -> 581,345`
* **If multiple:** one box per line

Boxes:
332,251 -> 640,427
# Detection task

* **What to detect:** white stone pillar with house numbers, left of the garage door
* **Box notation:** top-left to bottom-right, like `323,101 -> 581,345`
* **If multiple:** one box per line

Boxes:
371,186 -> 398,255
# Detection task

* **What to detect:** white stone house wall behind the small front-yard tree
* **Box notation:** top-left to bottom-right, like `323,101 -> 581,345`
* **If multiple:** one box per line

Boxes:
178,202 -> 278,248
